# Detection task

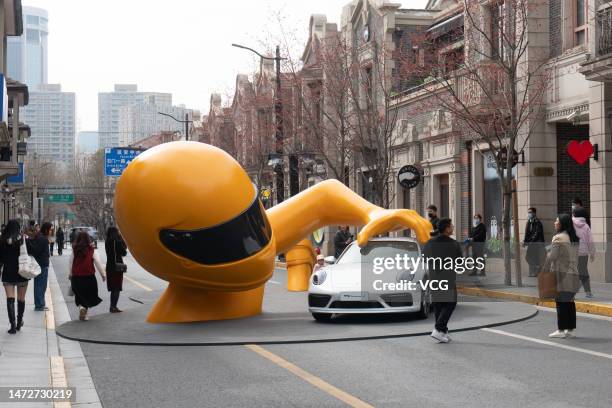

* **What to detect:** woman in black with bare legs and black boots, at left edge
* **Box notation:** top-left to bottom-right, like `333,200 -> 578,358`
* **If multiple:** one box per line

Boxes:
0,220 -> 28,334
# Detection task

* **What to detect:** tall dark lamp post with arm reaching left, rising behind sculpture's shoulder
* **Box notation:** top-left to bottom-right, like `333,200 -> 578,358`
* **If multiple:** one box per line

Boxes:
232,44 -> 299,204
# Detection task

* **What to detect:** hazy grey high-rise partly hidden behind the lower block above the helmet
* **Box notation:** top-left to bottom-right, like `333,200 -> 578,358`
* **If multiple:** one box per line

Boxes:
98,84 -> 172,148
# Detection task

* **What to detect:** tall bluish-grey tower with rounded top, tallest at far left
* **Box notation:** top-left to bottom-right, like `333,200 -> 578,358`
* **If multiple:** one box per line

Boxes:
6,6 -> 49,92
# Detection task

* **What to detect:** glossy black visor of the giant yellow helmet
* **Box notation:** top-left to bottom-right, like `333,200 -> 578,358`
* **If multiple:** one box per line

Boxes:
159,196 -> 272,265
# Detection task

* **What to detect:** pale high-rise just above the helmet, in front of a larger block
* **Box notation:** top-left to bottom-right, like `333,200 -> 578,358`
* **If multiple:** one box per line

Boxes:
119,95 -> 193,146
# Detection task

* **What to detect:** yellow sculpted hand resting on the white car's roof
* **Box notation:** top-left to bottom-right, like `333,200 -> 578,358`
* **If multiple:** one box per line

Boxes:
357,208 -> 433,247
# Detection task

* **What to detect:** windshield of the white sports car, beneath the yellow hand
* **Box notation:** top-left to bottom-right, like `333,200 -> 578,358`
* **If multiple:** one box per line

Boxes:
337,241 -> 419,264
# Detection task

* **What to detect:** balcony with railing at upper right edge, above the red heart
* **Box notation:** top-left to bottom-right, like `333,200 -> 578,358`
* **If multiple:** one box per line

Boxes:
580,3 -> 612,82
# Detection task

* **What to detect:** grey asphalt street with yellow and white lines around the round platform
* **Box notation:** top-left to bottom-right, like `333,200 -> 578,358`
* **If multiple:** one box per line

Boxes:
47,249 -> 612,407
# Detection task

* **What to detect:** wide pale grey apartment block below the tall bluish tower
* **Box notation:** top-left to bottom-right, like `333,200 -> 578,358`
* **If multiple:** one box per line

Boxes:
24,84 -> 76,167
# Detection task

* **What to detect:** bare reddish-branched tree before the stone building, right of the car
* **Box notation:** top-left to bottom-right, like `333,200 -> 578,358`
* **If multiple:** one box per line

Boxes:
398,0 -> 548,284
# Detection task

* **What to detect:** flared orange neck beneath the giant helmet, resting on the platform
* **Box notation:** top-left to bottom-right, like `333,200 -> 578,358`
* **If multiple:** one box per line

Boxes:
147,283 -> 264,323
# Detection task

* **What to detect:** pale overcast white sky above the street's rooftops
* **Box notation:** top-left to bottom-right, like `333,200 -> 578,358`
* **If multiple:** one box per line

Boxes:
22,0 -> 426,130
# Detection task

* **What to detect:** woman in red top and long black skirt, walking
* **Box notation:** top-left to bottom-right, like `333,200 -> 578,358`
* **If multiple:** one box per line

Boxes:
68,231 -> 106,320
